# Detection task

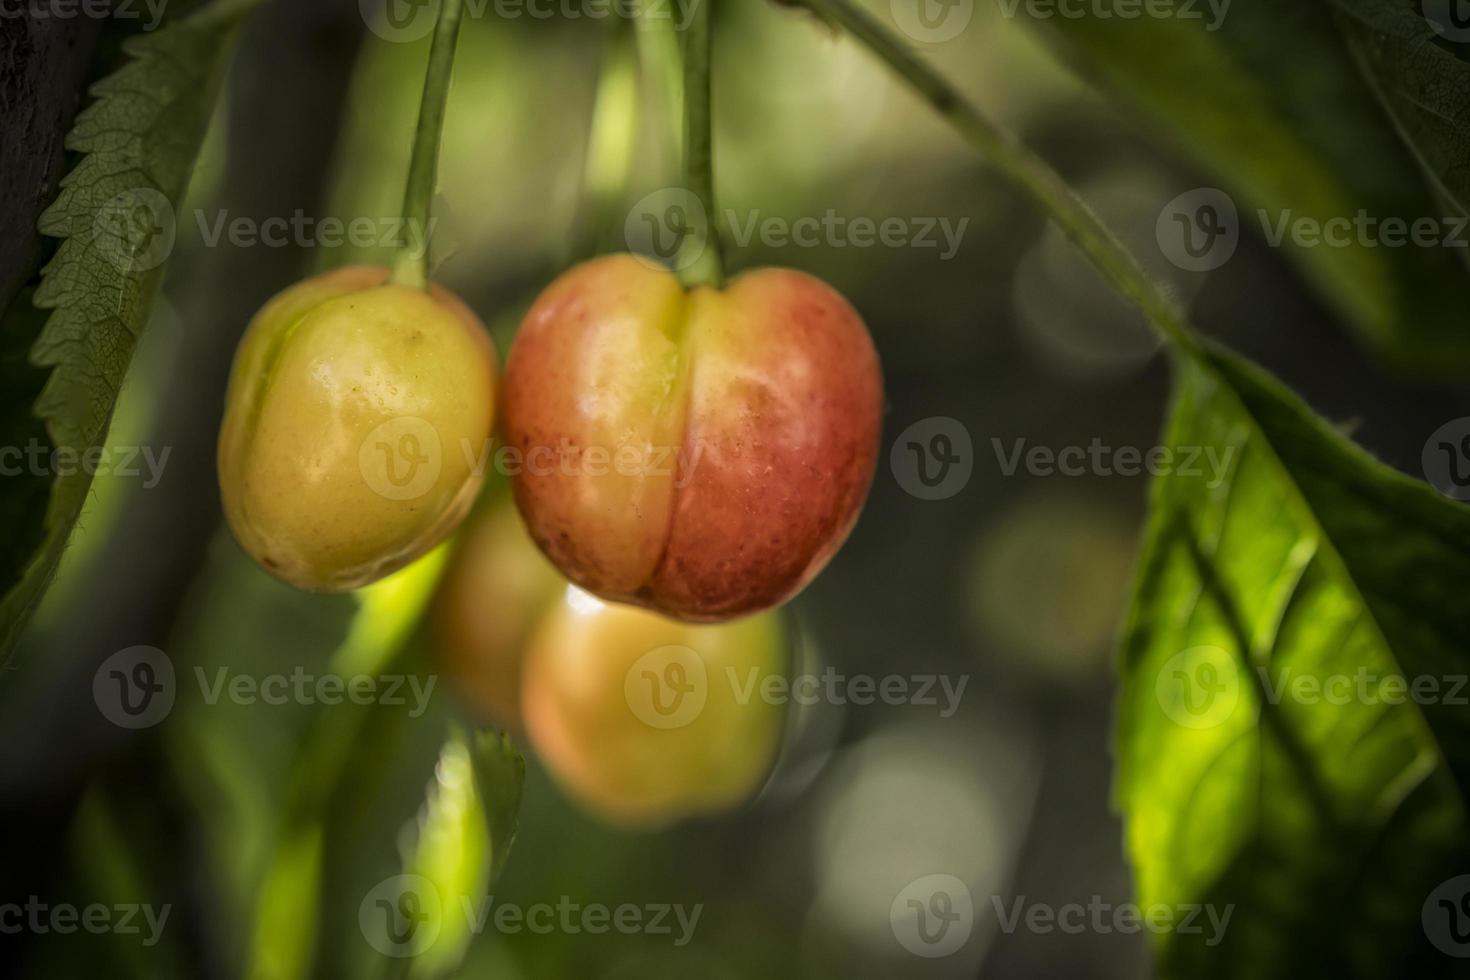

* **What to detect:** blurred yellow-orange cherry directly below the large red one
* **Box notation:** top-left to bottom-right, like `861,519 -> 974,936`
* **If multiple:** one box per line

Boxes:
522,586 -> 789,827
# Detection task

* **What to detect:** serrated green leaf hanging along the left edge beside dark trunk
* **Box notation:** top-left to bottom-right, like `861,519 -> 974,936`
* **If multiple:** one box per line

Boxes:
0,0 -> 259,658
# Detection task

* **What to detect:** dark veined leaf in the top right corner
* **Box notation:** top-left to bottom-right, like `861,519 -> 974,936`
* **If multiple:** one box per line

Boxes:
1332,0 -> 1470,215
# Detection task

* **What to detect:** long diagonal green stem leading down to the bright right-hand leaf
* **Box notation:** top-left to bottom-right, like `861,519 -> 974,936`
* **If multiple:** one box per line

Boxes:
801,0 -> 1201,354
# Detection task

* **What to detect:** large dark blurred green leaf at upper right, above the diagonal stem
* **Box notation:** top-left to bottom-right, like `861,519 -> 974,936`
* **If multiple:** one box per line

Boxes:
1022,0 -> 1470,370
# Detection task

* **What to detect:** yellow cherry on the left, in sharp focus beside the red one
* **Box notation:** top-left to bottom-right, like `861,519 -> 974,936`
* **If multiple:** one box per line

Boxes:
218,266 -> 495,592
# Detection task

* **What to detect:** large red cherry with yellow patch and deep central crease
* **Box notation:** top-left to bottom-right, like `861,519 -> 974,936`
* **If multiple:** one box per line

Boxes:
501,256 -> 883,621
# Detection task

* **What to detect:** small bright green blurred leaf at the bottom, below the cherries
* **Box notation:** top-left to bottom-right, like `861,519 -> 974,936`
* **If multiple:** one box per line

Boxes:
363,732 -> 525,980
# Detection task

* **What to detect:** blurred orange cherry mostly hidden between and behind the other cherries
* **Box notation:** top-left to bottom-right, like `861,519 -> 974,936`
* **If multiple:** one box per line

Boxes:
432,495 -> 566,730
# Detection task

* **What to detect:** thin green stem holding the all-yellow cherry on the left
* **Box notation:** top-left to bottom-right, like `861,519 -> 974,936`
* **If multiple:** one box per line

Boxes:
392,0 -> 460,289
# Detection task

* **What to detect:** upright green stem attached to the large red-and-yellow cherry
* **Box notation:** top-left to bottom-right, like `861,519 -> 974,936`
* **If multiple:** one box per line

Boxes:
679,0 -> 725,289
